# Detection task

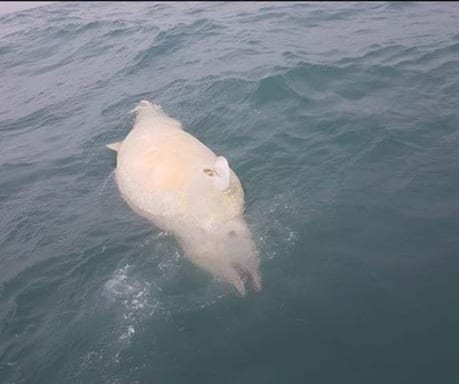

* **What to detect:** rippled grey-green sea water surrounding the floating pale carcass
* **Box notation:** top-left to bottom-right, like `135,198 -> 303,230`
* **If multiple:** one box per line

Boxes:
0,2 -> 459,384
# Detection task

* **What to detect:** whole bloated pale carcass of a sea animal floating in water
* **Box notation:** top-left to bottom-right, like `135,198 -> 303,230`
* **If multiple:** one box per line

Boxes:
108,100 -> 261,295
